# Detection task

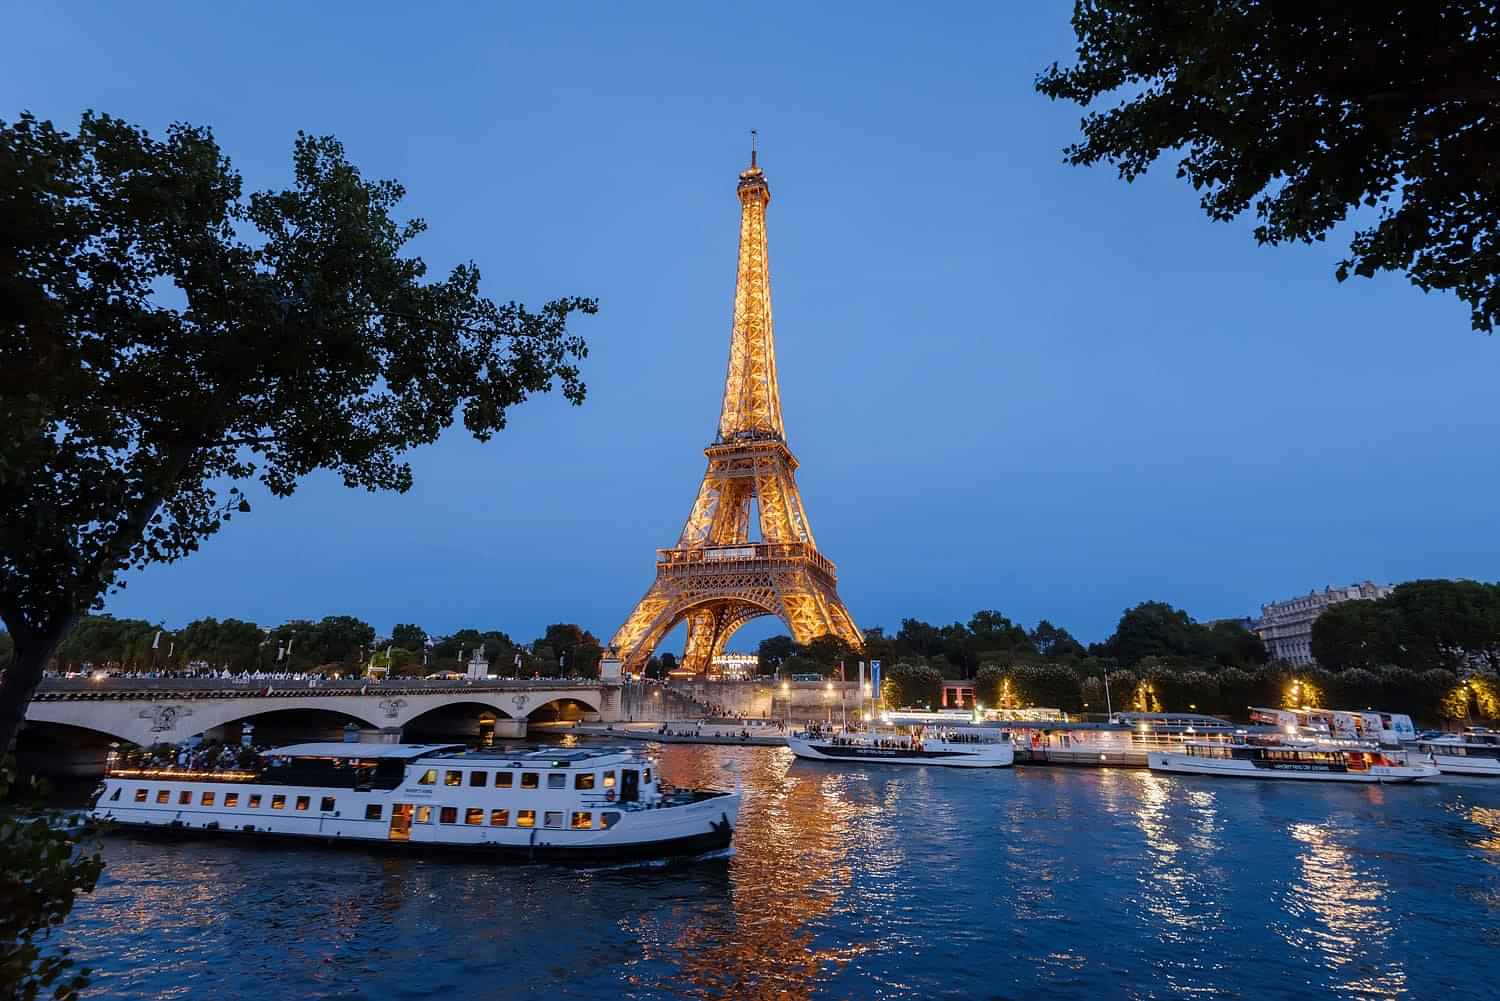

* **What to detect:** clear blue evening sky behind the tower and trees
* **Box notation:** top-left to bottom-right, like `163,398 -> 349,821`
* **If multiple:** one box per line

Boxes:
0,3 -> 1500,650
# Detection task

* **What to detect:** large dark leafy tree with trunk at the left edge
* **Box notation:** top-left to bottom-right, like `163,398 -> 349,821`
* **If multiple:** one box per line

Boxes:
0,113 -> 596,747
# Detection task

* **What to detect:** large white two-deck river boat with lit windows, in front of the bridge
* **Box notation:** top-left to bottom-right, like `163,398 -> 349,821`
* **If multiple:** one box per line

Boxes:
92,743 -> 740,861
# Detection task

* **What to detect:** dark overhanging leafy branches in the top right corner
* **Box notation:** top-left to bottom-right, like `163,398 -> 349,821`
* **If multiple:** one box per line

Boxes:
1037,0 -> 1500,332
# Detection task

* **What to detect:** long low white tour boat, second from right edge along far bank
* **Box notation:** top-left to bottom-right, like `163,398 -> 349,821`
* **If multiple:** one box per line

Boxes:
1146,741 -> 1439,782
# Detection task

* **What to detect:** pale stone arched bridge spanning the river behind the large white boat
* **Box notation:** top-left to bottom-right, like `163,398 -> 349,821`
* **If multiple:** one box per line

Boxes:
26,678 -> 621,744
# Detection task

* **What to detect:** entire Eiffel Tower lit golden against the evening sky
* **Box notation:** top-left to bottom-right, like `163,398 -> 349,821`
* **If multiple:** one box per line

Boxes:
611,149 -> 863,672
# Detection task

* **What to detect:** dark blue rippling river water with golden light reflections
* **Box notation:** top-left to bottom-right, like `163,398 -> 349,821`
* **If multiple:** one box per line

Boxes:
66,746 -> 1500,999
